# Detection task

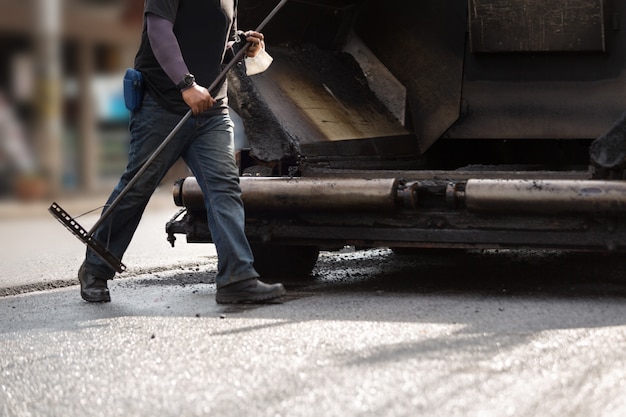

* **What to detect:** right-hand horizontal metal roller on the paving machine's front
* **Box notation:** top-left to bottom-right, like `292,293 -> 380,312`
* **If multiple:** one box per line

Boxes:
465,179 -> 626,215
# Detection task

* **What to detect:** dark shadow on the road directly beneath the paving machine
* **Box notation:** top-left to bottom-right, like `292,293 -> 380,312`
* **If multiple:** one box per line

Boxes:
304,249 -> 626,298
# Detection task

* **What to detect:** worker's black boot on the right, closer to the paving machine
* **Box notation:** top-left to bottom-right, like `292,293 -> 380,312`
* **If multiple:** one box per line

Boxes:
215,278 -> 287,304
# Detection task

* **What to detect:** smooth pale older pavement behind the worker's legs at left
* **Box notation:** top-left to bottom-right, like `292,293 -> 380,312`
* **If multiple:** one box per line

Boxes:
0,187 -> 216,295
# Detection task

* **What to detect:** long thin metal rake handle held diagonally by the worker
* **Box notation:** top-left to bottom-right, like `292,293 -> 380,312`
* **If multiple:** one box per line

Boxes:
88,0 -> 288,236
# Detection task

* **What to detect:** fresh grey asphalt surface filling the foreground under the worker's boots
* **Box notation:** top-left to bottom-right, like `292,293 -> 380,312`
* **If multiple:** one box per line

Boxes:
0,193 -> 626,417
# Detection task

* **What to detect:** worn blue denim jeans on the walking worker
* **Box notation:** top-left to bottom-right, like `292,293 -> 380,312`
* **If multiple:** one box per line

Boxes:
85,94 -> 259,288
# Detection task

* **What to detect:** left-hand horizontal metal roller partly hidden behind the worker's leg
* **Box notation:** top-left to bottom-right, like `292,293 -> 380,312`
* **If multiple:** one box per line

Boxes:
174,177 -> 398,211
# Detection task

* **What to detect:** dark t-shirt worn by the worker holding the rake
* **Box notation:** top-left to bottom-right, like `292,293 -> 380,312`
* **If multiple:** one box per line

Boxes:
135,0 -> 237,114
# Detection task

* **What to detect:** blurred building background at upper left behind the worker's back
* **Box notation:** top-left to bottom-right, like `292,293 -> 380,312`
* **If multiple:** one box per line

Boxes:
0,0 -> 143,199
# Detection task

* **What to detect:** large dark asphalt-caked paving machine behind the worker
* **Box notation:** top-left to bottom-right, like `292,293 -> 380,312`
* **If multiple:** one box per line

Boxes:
166,0 -> 626,275
